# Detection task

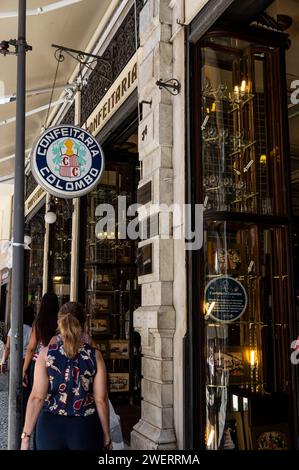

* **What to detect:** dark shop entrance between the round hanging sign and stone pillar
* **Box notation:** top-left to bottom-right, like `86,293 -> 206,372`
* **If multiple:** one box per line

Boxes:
80,117 -> 141,443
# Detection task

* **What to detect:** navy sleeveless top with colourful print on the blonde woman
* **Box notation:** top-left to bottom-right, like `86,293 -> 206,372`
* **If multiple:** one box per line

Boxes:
43,335 -> 96,416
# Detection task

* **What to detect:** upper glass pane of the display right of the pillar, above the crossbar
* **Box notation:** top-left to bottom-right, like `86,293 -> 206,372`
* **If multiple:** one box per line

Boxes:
200,35 -> 286,215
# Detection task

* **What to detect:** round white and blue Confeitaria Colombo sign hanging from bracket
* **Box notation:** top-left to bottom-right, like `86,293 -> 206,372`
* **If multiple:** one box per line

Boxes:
31,125 -> 104,199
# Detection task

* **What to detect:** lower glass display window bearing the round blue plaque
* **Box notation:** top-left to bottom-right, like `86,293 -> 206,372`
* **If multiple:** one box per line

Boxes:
202,222 -> 291,449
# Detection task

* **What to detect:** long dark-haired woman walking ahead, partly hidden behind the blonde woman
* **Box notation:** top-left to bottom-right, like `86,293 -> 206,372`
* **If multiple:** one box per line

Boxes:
23,293 -> 59,386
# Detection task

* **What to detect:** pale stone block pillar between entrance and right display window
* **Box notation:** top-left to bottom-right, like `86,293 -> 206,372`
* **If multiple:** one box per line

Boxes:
131,0 -> 176,450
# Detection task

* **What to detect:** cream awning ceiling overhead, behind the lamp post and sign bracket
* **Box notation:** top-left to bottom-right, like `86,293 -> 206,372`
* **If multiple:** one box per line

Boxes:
0,0 -> 111,177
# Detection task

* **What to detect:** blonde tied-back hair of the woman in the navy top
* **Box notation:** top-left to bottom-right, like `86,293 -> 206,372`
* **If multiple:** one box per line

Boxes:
58,302 -> 85,358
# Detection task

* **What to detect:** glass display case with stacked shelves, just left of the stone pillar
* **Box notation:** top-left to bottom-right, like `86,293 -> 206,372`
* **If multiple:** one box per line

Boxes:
84,162 -> 140,398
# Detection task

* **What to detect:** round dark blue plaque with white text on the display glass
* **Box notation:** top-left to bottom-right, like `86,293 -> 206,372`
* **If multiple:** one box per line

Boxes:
205,276 -> 247,323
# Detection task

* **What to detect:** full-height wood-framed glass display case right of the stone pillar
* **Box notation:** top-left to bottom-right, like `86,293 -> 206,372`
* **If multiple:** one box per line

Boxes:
197,31 -> 292,449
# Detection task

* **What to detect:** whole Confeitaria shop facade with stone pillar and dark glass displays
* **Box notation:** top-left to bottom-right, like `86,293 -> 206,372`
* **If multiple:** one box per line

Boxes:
21,0 -> 298,449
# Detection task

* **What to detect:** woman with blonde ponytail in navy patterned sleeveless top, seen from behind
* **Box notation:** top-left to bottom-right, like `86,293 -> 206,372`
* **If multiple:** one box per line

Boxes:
21,302 -> 112,450
